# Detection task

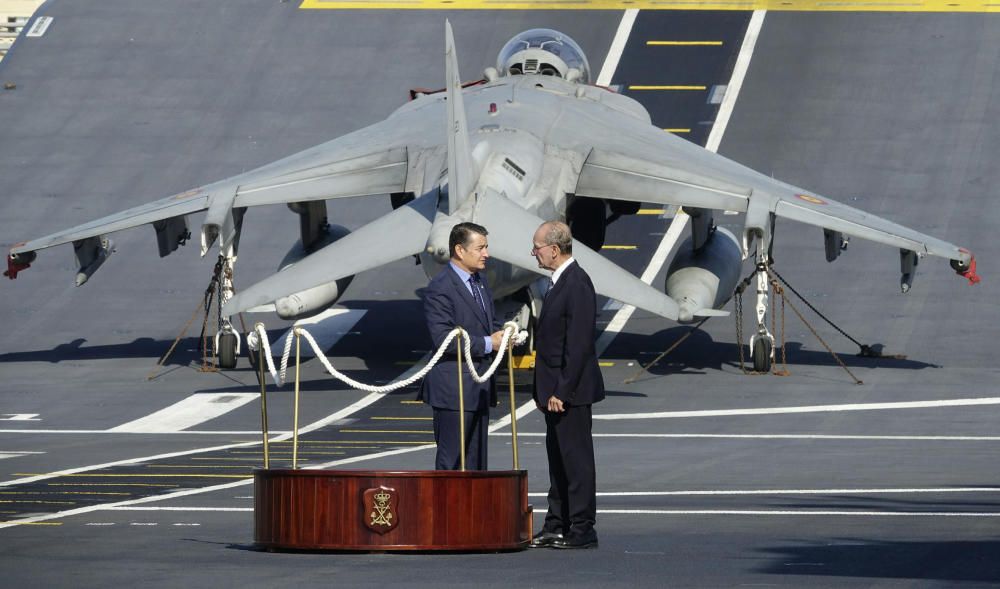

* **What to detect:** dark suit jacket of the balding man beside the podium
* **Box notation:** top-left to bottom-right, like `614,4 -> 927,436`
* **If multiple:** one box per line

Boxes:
534,261 -> 604,407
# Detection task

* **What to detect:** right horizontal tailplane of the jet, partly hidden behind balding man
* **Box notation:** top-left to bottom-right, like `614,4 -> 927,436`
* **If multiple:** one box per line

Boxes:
475,191 -> 679,320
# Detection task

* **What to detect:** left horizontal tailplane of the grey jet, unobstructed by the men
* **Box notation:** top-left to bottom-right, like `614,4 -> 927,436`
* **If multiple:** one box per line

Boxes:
222,192 -> 437,317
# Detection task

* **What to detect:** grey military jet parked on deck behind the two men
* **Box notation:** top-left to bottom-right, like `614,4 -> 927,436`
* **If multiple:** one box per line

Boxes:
5,22 -> 978,370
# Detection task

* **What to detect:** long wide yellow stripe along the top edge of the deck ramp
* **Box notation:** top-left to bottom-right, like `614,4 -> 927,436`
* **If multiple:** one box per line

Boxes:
299,0 -> 1000,13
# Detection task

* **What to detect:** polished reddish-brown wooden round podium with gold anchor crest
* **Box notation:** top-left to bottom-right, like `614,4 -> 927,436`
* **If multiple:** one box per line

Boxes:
254,469 -> 532,551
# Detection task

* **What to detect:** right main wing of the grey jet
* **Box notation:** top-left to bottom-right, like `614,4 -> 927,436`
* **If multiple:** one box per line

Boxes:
576,118 -> 971,264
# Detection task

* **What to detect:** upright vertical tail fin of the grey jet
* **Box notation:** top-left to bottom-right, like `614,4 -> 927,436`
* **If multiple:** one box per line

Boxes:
444,20 -> 475,214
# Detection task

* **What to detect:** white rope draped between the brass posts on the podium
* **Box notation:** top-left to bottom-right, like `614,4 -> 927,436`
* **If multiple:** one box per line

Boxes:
247,321 -> 528,394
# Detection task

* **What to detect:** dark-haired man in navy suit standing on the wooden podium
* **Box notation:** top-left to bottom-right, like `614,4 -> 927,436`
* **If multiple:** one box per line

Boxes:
417,223 -> 503,470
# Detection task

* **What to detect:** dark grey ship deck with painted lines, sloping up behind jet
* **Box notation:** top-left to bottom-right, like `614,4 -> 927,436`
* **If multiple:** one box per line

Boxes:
0,0 -> 1000,587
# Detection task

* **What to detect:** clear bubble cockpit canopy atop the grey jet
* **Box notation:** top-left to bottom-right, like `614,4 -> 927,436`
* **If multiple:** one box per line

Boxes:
497,29 -> 590,84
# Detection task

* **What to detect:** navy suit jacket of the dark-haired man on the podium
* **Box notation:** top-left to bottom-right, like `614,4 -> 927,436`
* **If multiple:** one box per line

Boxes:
417,265 -> 500,411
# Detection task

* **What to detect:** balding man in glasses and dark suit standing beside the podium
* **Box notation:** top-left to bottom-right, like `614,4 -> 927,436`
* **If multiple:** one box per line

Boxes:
531,221 -> 604,548
